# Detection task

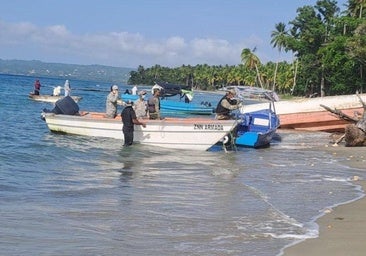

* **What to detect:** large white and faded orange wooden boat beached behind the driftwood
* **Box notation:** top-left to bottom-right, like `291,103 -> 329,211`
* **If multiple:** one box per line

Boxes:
242,94 -> 366,132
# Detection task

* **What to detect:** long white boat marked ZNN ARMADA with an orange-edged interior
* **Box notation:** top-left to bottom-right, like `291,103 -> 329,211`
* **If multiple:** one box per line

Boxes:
42,112 -> 237,150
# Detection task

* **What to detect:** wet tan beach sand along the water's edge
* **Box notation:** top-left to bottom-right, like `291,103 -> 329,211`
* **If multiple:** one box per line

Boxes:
283,144 -> 366,256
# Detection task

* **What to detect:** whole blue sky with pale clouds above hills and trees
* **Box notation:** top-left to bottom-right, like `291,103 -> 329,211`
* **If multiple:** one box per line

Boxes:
0,0 -> 347,68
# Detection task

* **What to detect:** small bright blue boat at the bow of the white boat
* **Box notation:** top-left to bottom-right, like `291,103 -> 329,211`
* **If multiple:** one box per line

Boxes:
235,102 -> 280,148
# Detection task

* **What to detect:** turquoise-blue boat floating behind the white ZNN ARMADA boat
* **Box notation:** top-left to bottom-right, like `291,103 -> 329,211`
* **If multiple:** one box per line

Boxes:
121,94 -> 214,115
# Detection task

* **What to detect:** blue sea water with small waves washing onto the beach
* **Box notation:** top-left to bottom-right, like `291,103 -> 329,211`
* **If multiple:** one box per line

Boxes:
0,75 -> 365,256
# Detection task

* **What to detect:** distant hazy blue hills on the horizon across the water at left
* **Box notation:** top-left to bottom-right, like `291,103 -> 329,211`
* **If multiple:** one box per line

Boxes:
0,59 -> 136,84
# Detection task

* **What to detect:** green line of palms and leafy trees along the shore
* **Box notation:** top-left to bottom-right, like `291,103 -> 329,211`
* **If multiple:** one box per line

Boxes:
128,0 -> 366,96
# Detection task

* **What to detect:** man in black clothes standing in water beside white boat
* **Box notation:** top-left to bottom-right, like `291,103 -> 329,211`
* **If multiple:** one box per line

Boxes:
121,101 -> 146,146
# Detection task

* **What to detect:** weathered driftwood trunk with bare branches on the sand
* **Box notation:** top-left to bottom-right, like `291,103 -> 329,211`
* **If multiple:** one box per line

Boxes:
320,94 -> 366,147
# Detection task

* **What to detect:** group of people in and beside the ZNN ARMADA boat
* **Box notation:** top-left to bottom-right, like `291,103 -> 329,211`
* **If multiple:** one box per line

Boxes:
106,85 -> 241,146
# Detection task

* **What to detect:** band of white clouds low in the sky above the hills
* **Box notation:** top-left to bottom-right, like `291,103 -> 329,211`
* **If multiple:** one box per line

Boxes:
0,20 -> 258,67
